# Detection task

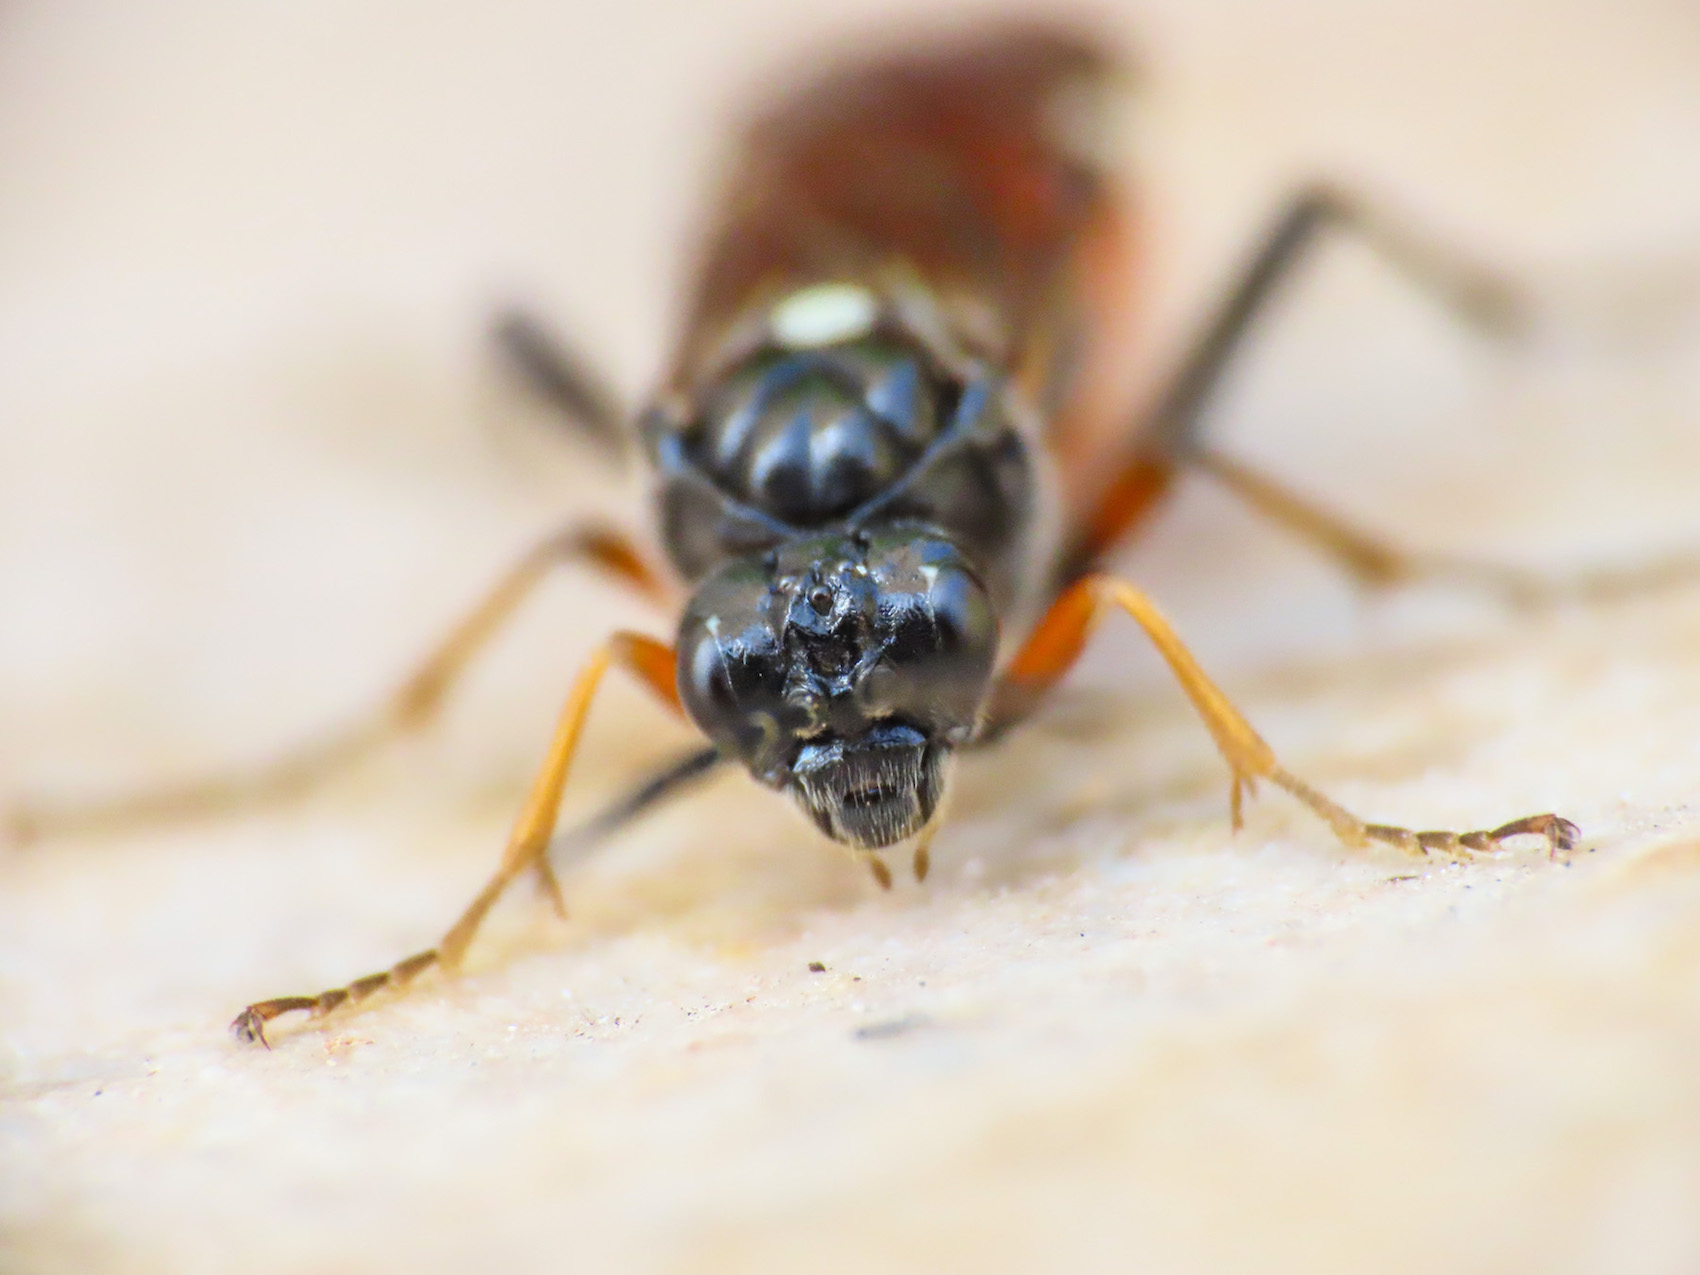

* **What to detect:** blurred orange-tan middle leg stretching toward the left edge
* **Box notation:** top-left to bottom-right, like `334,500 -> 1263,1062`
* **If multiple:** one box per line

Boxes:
7,527 -> 663,840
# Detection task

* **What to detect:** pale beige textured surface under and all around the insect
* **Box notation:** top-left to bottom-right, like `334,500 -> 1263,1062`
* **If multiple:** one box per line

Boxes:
0,0 -> 1700,1272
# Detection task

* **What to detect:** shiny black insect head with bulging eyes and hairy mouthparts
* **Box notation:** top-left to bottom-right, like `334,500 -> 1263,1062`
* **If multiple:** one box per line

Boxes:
678,525 -> 998,850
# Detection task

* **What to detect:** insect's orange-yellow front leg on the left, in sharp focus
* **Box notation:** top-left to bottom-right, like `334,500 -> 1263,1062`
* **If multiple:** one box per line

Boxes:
231,632 -> 683,1044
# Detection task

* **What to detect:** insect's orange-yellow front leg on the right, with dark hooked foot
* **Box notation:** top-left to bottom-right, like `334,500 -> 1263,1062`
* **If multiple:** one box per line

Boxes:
1005,575 -> 1578,857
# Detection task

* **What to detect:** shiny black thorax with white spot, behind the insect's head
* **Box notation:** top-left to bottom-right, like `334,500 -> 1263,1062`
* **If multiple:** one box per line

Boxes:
644,284 -> 1035,618
